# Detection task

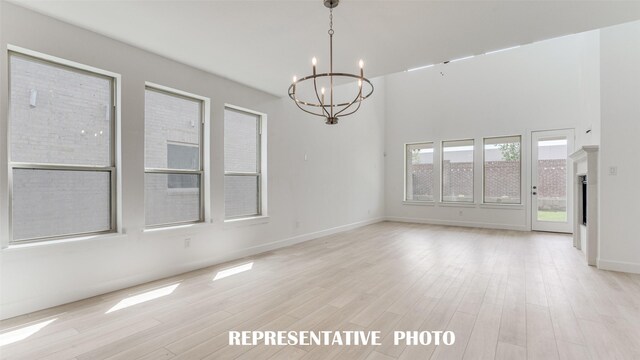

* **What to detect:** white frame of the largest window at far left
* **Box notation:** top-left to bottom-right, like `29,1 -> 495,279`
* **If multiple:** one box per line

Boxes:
6,45 -> 120,246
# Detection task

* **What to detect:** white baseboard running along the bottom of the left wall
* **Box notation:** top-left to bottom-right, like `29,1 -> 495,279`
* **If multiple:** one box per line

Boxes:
0,218 -> 384,320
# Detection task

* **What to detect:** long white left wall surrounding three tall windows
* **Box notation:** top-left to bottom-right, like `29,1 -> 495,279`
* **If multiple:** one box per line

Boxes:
0,2 -> 384,318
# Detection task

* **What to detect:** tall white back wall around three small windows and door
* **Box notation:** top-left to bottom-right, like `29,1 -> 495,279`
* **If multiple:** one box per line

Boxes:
385,31 -> 600,230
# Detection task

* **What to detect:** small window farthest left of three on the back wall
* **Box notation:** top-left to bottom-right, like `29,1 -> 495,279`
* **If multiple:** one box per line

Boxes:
405,143 -> 433,201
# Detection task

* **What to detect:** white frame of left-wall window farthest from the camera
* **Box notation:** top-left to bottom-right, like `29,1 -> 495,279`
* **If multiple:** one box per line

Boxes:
222,104 -> 267,222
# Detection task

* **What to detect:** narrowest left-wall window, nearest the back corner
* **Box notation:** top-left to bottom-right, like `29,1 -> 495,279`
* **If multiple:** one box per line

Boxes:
224,107 -> 262,219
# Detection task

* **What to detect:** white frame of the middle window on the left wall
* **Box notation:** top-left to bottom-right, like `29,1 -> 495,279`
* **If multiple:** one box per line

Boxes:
143,82 -> 209,229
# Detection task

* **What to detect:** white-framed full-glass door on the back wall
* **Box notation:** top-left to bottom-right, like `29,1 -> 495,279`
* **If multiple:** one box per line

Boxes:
531,129 -> 573,233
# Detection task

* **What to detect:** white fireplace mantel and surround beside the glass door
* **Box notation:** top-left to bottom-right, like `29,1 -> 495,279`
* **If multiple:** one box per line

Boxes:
569,145 -> 599,265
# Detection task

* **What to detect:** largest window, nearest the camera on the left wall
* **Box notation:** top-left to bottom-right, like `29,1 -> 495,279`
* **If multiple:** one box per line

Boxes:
9,51 -> 116,242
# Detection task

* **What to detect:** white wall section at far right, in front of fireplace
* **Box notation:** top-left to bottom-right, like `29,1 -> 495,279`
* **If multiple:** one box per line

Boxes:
598,22 -> 640,273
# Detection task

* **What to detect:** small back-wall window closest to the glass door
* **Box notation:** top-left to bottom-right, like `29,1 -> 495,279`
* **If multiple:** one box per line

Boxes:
483,136 -> 521,204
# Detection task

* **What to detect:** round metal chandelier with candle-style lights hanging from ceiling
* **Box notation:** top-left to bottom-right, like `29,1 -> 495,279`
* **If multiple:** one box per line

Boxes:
288,0 -> 373,125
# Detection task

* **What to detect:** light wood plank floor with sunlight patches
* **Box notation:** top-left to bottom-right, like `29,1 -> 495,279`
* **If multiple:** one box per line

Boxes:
0,222 -> 640,360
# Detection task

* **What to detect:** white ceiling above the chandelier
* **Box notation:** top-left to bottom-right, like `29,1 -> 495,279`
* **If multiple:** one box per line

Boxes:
8,0 -> 640,96
